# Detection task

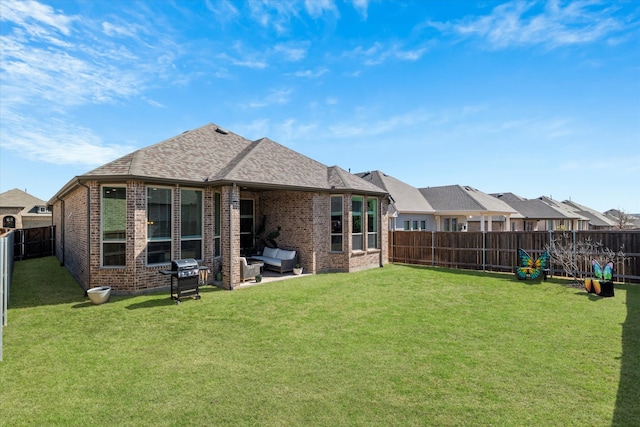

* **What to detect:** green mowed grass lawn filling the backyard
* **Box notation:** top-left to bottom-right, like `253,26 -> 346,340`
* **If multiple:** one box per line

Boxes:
0,258 -> 640,426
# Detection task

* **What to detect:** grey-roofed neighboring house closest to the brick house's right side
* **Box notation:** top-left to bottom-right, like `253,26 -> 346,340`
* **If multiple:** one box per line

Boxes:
356,171 -> 436,230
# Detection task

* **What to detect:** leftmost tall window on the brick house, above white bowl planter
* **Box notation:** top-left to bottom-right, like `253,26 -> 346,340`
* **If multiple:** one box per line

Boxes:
100,187 -> 127,267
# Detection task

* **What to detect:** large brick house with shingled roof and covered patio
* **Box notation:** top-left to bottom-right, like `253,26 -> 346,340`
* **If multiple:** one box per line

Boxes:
49,124 -> 389,293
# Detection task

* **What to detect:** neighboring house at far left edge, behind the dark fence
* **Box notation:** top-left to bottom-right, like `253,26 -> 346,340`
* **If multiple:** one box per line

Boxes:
0,188 -> 51,228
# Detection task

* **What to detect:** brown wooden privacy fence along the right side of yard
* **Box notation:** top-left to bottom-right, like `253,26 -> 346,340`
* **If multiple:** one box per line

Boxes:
388,230 -> 640,283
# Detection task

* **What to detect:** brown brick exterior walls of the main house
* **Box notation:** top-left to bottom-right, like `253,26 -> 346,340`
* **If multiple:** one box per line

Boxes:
53,181 -> 388,294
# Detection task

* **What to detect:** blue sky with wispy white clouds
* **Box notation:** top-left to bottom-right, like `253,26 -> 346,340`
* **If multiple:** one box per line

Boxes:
0,0 -> 640,213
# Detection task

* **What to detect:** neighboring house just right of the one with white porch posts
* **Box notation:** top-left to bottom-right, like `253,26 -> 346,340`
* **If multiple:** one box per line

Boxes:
492,193 -> 589,231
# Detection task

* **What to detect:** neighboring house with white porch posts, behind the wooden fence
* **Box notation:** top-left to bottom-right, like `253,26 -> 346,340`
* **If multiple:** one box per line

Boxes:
420,185 -> 516,231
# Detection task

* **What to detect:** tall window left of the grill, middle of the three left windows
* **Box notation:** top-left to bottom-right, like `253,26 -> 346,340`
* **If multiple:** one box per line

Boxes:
147,187 -> 172,264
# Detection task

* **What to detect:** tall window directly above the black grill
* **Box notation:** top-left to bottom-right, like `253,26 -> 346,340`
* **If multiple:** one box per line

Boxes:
180,190 -> 203,259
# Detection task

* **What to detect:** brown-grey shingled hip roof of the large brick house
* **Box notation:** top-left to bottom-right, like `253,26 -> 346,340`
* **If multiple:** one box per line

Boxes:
52,123 -> 385,199
